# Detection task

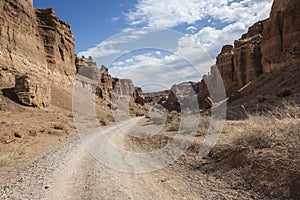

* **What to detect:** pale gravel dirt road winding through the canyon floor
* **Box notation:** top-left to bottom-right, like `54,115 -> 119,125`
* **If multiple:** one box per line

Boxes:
0,118 -> 268,200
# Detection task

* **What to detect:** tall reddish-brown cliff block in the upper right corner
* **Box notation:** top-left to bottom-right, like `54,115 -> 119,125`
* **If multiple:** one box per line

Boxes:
261,0 -> 300,73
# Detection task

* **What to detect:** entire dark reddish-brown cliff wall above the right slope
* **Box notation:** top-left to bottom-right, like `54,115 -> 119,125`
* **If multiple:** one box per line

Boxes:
216,0 -> 300,90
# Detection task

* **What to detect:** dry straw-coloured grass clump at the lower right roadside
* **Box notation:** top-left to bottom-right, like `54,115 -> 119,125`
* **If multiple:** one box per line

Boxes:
212,105 -> 300,199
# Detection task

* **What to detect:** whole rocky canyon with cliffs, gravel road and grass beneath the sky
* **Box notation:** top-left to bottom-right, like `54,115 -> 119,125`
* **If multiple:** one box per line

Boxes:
0,0 -> 300,199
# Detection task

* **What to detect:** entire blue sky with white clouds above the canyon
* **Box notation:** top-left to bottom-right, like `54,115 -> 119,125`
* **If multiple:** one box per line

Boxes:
34,0 -> 272,92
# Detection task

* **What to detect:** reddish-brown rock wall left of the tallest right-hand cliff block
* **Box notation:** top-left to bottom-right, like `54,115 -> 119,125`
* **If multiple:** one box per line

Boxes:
216,21 -> 263,90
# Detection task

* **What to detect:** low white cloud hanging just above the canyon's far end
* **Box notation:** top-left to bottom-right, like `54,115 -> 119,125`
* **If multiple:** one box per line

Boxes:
109,36 -> 213,92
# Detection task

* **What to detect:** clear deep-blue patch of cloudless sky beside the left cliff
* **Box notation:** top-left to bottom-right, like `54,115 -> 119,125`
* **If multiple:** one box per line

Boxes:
34,0 -> 135,52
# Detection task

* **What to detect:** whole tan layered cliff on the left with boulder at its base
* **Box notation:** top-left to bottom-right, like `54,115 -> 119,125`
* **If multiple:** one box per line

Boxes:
0,0 -> 76,107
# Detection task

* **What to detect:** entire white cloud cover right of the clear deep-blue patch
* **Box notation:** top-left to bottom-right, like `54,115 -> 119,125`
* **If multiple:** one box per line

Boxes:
80,0 -> 272,91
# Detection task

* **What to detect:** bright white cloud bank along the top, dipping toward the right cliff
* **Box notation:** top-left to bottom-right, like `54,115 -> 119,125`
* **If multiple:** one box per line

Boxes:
126,0 -> 272,57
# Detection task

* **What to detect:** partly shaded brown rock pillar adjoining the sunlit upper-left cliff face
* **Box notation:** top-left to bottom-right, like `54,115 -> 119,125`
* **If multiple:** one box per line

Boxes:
35,8 -> 76,84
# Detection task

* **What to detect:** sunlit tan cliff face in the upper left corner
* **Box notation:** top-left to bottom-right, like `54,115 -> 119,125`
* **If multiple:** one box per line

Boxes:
0,0 -> 47,85
